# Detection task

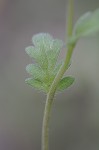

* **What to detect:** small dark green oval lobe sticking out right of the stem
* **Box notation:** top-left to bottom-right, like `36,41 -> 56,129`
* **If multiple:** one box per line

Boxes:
57,77 -> 74,91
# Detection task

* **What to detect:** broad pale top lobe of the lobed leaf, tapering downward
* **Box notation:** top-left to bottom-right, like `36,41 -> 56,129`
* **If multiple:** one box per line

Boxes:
32,33 -> 63,70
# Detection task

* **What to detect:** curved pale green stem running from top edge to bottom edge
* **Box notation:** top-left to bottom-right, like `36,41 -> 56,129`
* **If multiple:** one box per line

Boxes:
42,0 -> 75,150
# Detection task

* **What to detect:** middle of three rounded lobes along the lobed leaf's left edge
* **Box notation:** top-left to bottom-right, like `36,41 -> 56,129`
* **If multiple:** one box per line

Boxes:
26,64 -> 46,81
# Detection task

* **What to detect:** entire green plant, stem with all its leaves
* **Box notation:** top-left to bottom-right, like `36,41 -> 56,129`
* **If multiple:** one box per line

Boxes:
25,4 -> 99,150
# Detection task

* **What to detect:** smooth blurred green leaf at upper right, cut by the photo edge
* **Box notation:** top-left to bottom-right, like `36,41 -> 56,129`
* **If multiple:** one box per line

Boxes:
73,9 -> 99,39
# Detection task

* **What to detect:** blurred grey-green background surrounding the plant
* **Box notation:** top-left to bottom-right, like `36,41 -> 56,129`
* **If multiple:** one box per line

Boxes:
0,0 -> 99,150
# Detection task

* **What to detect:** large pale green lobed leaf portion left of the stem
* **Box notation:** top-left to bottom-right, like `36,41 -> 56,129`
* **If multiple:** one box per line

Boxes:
26,33 -> 66,92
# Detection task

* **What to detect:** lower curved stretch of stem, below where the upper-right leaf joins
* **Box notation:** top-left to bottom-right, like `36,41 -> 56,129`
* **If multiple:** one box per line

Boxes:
42,45 -> 75,150
